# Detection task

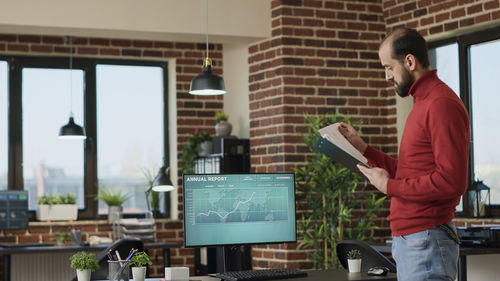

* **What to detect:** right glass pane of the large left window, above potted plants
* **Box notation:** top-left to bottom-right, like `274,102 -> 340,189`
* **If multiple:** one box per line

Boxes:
97,65 -> 164,214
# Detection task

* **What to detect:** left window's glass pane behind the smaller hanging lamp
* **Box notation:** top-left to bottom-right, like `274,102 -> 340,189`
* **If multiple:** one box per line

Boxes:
22,68 -> 85,210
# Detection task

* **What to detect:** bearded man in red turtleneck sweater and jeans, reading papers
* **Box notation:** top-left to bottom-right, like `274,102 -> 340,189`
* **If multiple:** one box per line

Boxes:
339,28 -> 470,281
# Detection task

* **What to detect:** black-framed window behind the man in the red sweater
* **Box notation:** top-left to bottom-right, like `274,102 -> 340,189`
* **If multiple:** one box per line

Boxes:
429,28 -> 500,216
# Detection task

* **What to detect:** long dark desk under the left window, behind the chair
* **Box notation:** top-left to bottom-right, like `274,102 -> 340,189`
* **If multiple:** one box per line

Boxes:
0,242 -> 180,281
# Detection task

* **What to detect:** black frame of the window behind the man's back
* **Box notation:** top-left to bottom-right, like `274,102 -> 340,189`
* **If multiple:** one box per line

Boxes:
427,27 -> 500,218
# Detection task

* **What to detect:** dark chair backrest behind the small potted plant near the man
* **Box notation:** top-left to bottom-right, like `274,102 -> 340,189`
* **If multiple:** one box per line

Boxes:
337,240 -> 396,273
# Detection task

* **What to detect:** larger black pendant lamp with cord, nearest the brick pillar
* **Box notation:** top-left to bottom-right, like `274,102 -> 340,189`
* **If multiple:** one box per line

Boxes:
189,0 -> 226,96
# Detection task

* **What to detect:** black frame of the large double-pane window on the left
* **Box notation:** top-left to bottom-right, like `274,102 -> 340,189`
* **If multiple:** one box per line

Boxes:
0,55 -> 171,220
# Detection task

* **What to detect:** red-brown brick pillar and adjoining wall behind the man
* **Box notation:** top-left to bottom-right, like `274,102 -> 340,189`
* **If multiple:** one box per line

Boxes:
249,0 -> 500,268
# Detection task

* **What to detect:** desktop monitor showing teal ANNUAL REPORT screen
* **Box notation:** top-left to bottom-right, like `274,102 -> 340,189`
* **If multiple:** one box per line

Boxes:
183,173 -> 297,247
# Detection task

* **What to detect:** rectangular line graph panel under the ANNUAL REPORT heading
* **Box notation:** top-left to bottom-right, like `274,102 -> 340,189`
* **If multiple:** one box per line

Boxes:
188,187 -> 288,224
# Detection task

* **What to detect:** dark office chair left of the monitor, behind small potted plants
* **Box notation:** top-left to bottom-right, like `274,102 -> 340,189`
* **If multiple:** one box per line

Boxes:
73,237 -> 144,281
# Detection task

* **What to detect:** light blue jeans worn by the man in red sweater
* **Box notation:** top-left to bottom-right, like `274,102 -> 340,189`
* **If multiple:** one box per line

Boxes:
392,223 -> 459,281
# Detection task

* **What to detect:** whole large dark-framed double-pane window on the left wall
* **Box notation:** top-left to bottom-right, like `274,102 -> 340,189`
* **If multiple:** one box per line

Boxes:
0,56 -> 170,219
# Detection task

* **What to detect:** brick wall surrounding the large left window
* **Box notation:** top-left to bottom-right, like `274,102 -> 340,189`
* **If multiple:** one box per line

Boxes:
0,34 -> 223,276
